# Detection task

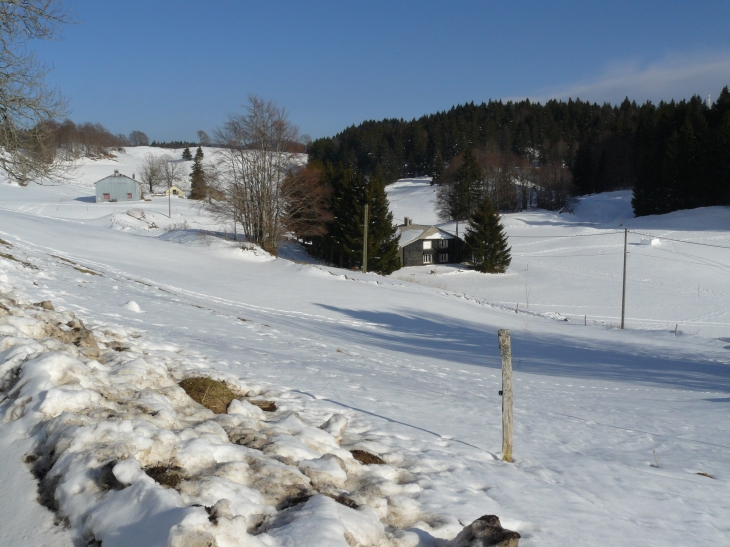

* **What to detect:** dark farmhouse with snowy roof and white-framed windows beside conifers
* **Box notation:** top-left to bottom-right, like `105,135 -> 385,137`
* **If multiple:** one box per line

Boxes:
398,217 -> 463,267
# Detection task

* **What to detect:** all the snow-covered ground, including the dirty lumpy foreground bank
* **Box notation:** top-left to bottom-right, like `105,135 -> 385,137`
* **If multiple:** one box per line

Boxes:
0,155 -> 730,547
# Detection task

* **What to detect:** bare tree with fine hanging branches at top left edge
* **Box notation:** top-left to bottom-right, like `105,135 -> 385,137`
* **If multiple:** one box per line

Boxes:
0,0 -> 72,186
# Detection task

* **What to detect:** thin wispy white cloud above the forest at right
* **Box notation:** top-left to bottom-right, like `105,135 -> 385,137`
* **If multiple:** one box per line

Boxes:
513,51 -> 730,104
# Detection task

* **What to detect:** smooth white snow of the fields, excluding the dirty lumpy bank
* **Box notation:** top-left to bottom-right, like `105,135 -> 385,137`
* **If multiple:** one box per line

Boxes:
0,155 -> 730,547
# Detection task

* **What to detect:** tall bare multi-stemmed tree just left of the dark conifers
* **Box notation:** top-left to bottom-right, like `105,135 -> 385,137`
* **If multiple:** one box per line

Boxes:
209,96 -> 301,252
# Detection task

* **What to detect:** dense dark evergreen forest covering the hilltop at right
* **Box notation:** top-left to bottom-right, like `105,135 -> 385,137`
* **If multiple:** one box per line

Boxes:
307,87 -> 730,216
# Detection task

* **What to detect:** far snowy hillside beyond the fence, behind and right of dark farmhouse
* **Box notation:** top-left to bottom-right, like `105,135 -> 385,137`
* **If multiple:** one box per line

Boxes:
388,179 -> 730,338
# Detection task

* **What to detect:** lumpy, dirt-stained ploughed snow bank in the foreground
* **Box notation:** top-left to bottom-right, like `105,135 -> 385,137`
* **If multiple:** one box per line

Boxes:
0,288 -> 472,547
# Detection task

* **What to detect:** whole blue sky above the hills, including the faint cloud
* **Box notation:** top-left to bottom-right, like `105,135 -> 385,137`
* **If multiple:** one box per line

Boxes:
34,0 -> 730,140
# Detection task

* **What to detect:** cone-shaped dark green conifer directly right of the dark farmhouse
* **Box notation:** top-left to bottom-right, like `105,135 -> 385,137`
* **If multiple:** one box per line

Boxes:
464,197 -> 512,273
